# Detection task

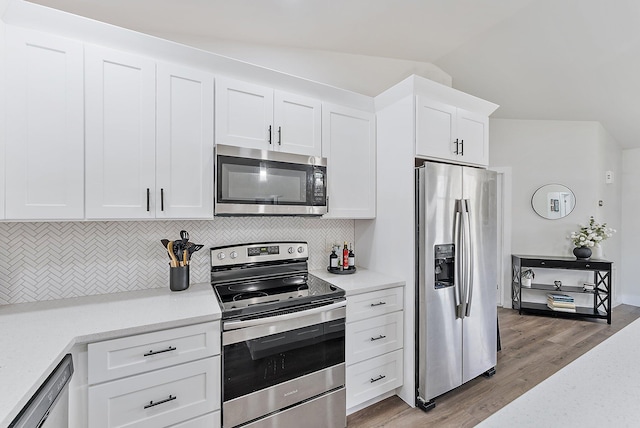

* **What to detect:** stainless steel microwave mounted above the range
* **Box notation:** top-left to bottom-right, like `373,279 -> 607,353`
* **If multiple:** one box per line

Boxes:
214,144 -> 327,215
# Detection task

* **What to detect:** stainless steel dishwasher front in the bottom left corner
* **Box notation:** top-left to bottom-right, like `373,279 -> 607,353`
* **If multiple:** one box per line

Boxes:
9,354 -> 73,428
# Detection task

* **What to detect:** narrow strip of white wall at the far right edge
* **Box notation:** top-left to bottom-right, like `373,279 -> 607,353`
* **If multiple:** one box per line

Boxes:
617,149 -> 640,306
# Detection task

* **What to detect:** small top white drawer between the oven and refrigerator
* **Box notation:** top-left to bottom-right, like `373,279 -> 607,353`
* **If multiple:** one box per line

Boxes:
347,287 -> 403,322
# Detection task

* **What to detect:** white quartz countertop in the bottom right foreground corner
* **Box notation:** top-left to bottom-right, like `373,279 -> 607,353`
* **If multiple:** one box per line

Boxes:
478,320 -> 640,428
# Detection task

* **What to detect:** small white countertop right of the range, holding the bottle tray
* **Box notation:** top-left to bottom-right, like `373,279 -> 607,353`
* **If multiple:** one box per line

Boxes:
309,268 -> 405,296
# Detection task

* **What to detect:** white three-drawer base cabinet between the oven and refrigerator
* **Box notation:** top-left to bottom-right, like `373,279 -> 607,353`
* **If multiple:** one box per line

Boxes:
345,287 -> 404,413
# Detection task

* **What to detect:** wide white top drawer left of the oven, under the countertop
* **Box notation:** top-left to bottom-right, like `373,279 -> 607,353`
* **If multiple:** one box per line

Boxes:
88,322 -> 220,385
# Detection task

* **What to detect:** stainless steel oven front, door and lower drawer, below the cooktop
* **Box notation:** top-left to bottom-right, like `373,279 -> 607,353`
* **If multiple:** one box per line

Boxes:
222,300 -> 346,427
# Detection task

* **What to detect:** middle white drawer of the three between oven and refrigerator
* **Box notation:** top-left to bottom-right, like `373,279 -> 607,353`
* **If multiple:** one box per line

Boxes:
345,311 -> 404,365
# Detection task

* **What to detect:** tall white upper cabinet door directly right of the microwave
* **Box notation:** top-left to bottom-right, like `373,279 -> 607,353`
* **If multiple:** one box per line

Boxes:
322,104 -> 376,218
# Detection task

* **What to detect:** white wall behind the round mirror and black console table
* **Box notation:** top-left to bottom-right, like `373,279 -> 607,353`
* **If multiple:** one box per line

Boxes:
489,119 -> 622,301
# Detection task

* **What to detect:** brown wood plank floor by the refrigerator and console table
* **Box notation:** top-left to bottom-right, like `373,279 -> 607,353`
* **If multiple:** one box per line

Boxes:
347,305 -> 640,428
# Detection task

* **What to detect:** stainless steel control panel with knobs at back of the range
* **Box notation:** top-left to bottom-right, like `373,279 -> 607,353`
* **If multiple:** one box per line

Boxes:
210,242 -> 309,267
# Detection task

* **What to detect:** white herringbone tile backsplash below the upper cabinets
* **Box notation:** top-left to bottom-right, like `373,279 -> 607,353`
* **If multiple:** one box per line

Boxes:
0,217 -> 357,304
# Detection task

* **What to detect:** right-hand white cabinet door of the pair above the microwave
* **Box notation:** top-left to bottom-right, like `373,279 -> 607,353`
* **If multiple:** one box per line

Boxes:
273,91 -> 322,157
